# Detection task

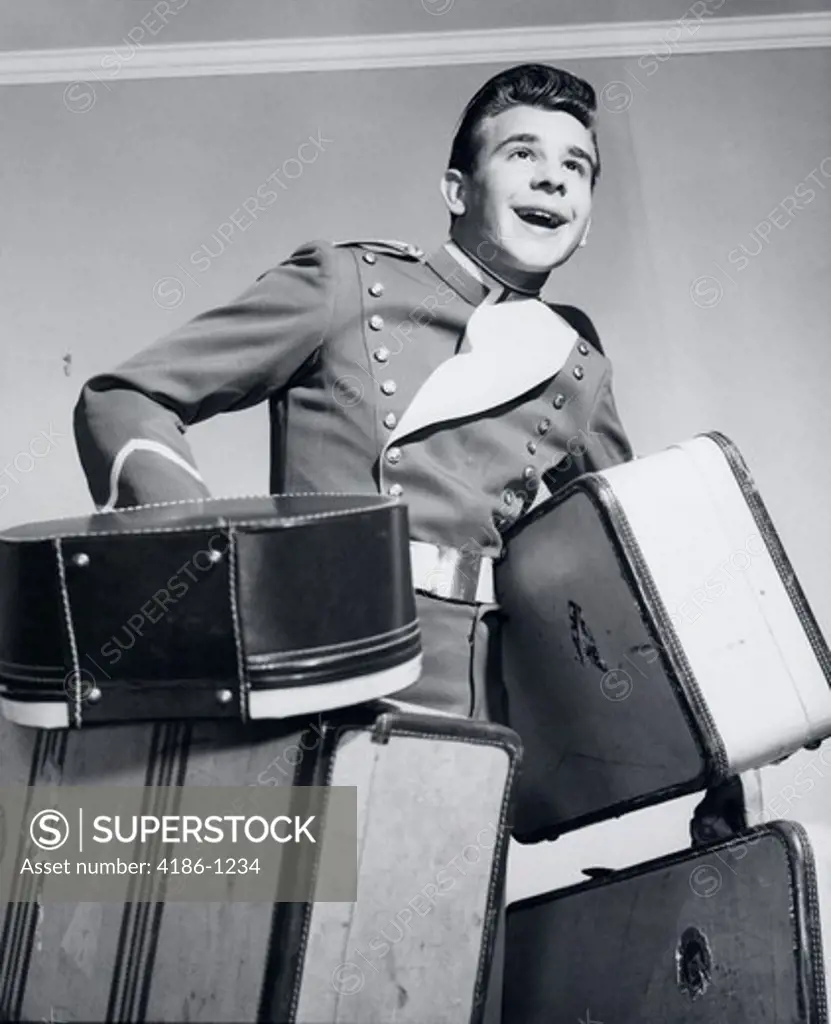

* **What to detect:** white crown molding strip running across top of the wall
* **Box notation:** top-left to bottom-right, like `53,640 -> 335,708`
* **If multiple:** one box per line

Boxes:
0,13 -> 831,85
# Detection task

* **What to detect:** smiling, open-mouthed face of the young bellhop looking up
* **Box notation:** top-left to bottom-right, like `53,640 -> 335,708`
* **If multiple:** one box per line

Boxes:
442,106 -> 597,273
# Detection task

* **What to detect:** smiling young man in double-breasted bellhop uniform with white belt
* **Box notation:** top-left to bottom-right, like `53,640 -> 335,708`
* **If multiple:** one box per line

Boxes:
76,65 -> 631,717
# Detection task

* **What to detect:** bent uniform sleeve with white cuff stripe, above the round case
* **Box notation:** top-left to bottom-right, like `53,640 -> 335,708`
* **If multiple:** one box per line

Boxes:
75,243 -> 335,509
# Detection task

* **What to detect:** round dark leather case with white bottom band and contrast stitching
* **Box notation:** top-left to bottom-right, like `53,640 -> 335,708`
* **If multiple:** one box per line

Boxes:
0,495 -> 421,728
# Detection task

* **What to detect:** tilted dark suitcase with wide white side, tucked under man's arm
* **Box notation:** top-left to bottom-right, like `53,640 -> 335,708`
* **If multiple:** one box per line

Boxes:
495,433 -> 831,842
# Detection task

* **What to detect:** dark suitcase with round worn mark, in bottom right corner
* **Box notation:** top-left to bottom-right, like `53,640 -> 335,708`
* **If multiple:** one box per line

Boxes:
502,821 -> 831,1024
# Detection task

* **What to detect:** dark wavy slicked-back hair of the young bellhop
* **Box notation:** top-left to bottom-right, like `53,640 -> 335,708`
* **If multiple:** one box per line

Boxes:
447,65 -> 600,187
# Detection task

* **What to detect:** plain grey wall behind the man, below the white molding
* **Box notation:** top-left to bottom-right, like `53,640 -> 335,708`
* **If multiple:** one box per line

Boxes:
0,37 -> 831,882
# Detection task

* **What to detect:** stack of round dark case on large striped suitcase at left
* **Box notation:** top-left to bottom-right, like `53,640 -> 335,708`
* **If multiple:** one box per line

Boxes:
0,496 -> 519,1024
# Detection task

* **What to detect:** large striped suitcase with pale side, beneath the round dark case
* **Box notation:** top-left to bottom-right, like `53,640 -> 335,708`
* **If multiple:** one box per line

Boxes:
0,705 -> 519,1024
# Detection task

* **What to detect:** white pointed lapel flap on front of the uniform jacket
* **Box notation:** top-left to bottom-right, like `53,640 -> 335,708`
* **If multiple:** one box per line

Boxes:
386,296 -> 577,446
